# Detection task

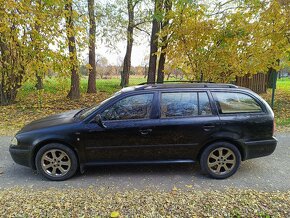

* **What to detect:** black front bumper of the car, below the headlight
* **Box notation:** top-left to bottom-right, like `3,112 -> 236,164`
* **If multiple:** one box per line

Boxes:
9,145 -> 32,167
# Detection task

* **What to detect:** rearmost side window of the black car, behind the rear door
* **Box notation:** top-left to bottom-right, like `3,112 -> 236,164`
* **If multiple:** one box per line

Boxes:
213,92 -> 262,114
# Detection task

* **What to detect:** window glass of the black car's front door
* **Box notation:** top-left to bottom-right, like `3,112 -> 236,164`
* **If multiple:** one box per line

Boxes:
101,94 -> 153,120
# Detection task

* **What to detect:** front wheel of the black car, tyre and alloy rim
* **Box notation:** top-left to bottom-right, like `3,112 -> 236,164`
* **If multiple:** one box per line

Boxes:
35,143 -> 78,181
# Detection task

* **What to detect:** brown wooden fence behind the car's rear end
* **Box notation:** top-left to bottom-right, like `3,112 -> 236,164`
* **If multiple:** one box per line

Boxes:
236,73 -> 268,94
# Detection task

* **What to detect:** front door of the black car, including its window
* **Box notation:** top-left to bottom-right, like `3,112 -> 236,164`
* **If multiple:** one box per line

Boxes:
85,92 -> 162,163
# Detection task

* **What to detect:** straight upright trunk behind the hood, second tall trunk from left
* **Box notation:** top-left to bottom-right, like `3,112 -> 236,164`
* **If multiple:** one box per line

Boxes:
87,0 -> 97,93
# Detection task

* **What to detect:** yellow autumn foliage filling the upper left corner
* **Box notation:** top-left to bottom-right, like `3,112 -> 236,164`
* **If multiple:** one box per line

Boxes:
0,0 -> 87,104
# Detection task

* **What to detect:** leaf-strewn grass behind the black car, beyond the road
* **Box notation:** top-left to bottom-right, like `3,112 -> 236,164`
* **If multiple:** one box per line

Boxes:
0,76 -> 290,135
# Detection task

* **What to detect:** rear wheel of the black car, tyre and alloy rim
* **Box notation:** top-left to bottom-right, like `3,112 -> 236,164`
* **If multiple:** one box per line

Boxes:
200,142 -> 241,179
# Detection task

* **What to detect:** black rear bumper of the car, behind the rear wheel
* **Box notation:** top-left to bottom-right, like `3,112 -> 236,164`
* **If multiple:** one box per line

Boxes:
243,136 -> 278,160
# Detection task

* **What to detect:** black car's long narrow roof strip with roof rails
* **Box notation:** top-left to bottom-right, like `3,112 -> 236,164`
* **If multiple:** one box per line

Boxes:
121,83 -> 239,92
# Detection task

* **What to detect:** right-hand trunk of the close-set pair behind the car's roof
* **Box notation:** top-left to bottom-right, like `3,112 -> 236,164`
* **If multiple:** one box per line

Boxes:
157,0 -> 172,83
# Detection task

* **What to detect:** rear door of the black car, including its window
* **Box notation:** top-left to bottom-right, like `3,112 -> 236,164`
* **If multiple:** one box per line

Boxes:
155,91 -> 219,160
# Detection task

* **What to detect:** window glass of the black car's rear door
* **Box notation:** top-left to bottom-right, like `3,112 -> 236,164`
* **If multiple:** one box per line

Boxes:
160,92 -> 212,118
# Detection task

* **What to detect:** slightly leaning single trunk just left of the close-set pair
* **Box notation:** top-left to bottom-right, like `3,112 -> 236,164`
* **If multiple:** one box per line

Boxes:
120,0 -> 134,87
